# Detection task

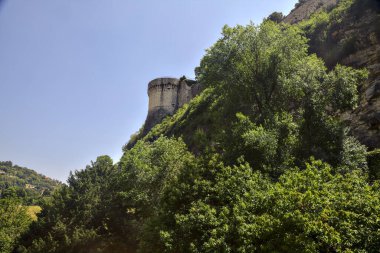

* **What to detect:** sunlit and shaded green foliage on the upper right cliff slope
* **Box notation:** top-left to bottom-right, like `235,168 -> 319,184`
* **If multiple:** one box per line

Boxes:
298,0 -> 380,68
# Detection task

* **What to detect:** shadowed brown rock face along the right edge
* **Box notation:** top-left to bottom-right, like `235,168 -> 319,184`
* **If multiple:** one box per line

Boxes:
340,7 -> 380,148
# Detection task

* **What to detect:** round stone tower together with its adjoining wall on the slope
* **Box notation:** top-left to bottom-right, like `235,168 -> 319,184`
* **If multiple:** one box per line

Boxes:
143,77 -> 201,134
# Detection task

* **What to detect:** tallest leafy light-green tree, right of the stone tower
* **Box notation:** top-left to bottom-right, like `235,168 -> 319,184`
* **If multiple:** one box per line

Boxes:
196,21 -> 367,176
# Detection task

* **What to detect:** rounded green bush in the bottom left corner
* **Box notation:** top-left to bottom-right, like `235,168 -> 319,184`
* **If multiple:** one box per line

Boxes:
0,198 -> 32,253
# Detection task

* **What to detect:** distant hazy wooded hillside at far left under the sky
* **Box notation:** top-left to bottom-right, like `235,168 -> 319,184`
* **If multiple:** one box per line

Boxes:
0,161 -> 61,205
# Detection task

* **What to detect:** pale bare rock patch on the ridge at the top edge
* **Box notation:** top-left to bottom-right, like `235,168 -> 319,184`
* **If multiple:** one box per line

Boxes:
283,0 -> 338,24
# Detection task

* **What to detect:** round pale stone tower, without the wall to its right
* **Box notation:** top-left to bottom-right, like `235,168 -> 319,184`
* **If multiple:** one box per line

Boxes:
144,77 -> 180,132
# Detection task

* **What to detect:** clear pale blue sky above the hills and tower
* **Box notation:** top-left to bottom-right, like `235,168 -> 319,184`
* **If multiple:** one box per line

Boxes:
0,0 -> 297,181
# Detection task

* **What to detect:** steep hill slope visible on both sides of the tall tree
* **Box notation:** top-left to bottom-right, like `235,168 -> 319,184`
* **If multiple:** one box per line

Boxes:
126,0 -> 380,151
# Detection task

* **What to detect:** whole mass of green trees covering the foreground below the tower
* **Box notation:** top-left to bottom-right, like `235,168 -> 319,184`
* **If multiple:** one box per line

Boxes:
4,0 -> 380,253
